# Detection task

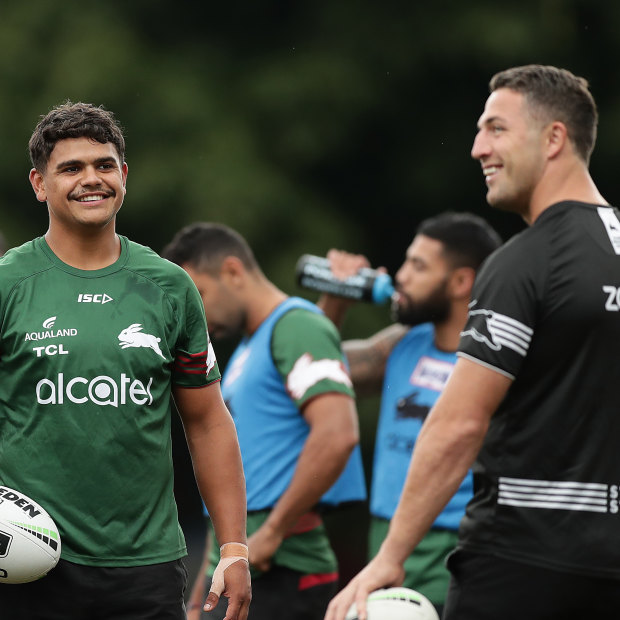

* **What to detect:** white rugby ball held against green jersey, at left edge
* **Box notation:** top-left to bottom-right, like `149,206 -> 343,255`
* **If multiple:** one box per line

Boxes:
0,486 -> 61,583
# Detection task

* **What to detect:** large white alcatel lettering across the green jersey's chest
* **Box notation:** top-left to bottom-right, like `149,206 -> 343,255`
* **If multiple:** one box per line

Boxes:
36,372 -> 153,407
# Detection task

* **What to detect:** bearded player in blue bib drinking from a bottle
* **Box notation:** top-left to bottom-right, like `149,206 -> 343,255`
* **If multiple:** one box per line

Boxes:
319,212 -> 501,615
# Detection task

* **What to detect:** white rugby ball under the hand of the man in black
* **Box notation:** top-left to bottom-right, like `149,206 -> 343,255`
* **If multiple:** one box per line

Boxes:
345,588 -> 439,620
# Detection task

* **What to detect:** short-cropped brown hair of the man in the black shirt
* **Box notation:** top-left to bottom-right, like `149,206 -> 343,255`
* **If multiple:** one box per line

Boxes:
489,65 -> 598,164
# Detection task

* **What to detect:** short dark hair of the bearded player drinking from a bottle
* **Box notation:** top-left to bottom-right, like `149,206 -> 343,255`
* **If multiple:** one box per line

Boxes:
416,211 -> 502,270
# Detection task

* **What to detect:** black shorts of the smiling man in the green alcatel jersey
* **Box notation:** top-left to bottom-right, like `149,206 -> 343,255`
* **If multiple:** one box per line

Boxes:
0,560 -> 187,620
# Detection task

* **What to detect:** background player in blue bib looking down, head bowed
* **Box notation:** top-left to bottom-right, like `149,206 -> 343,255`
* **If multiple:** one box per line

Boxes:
163,223 -> 365,620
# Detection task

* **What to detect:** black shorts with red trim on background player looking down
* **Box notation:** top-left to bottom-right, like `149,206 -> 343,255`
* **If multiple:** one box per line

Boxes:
200,566 -> 338,620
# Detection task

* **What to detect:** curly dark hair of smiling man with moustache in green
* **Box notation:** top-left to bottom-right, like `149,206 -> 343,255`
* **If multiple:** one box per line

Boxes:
28,101 -> 125,172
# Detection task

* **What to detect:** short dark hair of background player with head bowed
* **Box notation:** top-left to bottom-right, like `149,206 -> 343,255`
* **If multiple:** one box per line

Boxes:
162,222 -> 258,277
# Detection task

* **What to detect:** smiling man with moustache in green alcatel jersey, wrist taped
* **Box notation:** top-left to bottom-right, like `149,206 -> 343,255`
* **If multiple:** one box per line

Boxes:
0,102 -> 251,620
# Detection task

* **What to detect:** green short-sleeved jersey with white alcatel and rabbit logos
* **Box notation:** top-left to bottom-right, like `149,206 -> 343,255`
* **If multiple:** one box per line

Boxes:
0,237 -> 220,566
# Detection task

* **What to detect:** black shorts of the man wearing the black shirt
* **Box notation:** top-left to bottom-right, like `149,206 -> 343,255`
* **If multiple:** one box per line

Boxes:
442,550 -> 620,620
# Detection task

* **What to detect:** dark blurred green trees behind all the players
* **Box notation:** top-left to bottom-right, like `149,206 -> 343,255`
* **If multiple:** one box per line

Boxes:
0,0 -> 620,289
